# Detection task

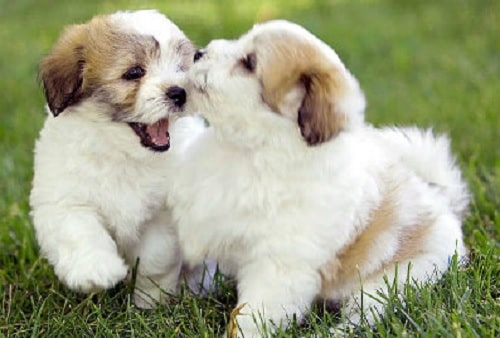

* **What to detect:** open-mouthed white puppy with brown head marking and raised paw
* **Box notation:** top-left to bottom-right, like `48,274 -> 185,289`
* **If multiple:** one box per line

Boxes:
30,10 -> 211,307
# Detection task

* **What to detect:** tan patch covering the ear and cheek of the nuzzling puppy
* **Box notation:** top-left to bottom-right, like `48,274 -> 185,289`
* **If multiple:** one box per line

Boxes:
255,31 -> 347,145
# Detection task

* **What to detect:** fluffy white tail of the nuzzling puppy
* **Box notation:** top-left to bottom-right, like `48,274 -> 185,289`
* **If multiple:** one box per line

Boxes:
382,127 -> 470,218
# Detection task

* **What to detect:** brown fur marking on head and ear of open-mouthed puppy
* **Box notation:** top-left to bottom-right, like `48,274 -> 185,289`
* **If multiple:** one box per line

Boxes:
40,16 -> 159,119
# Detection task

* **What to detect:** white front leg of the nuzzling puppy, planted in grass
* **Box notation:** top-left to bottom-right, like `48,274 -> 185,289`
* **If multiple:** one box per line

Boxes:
229,261 -> 320,338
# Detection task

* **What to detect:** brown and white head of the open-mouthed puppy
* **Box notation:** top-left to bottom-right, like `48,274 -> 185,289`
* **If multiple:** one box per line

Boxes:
40,10 -> 195,151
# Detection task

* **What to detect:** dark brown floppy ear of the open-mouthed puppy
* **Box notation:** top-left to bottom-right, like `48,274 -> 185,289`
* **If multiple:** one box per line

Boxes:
39,25 -> 86,116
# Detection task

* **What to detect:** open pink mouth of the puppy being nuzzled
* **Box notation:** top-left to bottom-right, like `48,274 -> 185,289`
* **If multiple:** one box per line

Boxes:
129,119 -> 170,151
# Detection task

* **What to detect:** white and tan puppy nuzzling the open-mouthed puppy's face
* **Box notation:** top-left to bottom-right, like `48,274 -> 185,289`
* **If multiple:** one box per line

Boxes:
168,21 -> 469,338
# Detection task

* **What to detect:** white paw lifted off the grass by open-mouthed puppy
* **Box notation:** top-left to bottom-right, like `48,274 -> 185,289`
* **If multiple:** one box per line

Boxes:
55,250 -> 128,293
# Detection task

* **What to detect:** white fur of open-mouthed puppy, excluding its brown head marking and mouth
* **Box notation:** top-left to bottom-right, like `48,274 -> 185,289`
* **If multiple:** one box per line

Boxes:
30,10 -> 213,307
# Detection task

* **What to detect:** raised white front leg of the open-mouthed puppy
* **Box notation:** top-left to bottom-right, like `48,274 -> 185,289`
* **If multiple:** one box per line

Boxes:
33,207 -> 127,292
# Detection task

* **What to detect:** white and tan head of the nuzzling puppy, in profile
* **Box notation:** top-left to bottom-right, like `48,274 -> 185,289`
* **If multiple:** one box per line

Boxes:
188,21 -> 365,145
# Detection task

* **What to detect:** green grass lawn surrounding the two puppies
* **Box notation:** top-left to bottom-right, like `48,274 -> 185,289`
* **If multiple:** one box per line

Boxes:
0,0 -> 500,337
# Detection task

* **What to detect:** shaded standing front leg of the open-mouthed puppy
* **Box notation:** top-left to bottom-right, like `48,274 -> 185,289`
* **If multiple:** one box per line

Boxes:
129,212 -> 181,308
